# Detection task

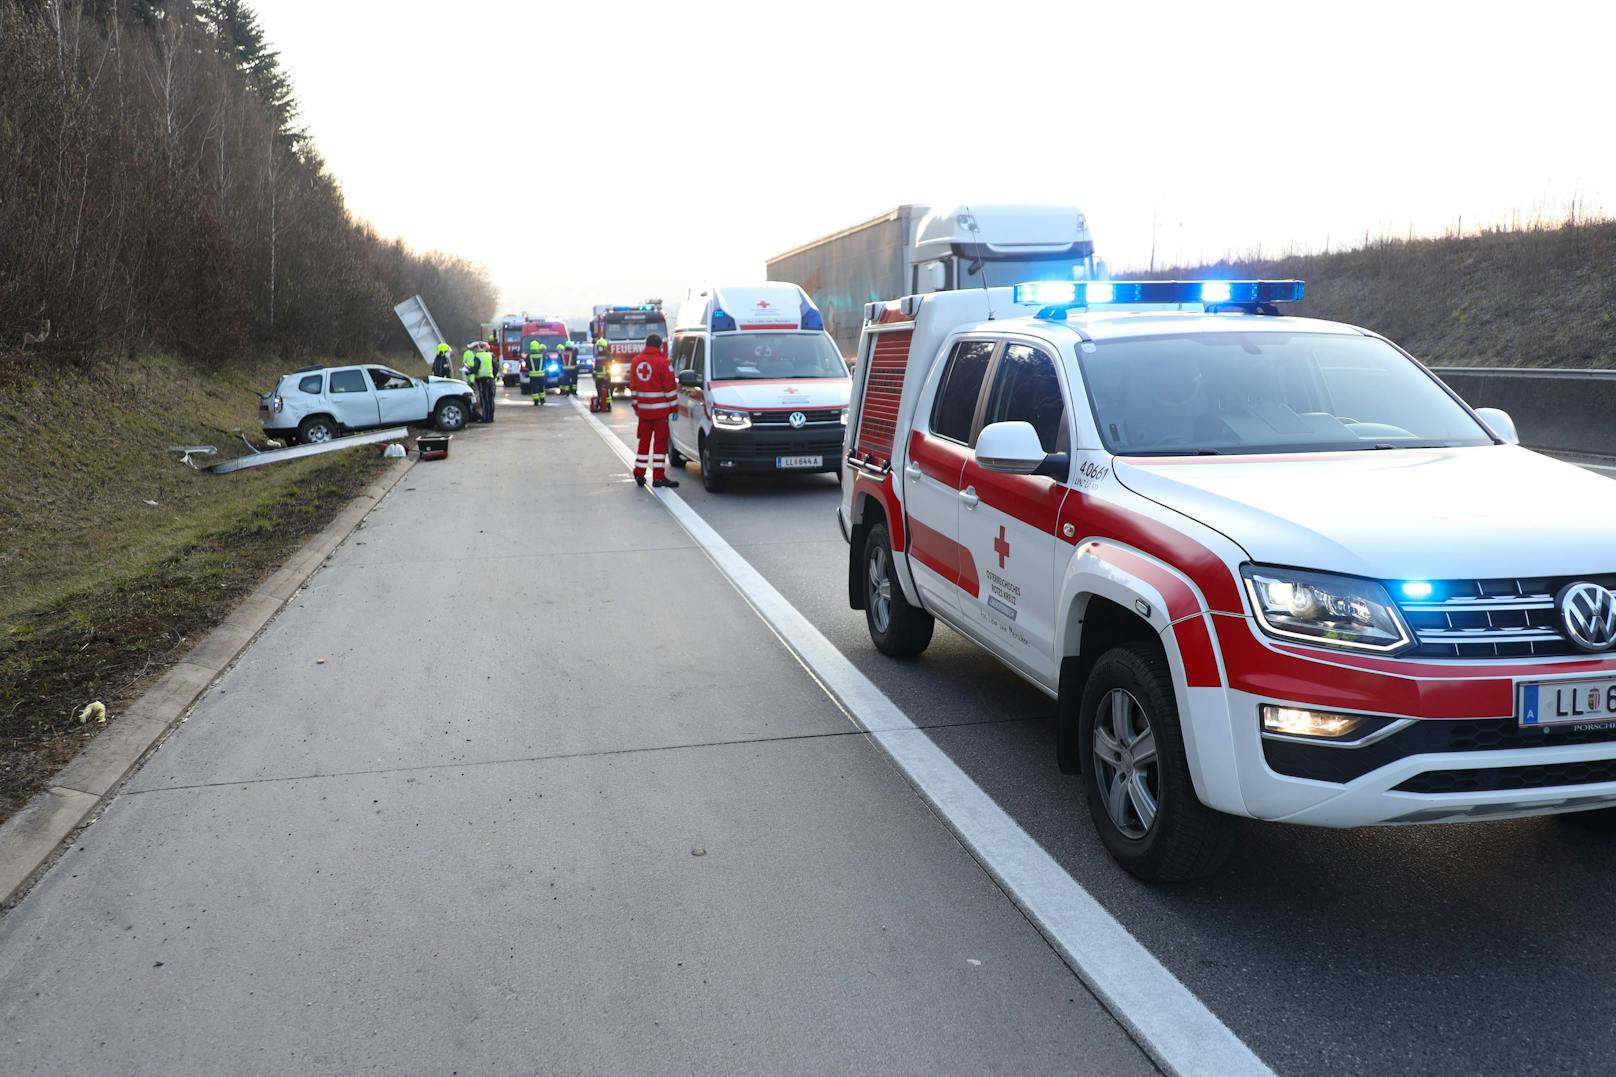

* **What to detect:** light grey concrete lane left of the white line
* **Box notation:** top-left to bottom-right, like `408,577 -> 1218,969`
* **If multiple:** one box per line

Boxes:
0,391 -> 1157,1075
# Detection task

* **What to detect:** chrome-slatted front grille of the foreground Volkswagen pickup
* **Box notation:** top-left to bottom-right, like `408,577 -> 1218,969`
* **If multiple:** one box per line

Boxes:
1398,576 -> 1616,658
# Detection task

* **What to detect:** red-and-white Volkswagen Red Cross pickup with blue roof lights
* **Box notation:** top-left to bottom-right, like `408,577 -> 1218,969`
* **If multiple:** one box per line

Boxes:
839,281 -> 1616,880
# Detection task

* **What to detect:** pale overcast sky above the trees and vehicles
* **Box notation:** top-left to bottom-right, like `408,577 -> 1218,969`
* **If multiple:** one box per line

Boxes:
255,0 -> 1616,325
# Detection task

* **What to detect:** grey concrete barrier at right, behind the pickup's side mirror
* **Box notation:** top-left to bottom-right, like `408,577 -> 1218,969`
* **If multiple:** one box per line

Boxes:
1432,367 -> 1616,456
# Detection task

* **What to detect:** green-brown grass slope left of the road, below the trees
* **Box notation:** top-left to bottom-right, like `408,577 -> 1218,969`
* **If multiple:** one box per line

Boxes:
0,359 -> 394,818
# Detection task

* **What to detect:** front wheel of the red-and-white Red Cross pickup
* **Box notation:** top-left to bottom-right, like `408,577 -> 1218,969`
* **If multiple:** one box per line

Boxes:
1078,642 -> 1235,883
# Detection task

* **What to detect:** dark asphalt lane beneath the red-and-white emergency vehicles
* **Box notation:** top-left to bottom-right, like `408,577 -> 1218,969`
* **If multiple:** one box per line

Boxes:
591,381 -> 1616,1074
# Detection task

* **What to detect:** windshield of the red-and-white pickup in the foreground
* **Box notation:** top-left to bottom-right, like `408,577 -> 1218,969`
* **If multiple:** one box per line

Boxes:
1079,333 -> 1492,456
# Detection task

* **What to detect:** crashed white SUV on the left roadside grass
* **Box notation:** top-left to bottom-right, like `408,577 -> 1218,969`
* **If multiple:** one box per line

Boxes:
259,364 -> 472,445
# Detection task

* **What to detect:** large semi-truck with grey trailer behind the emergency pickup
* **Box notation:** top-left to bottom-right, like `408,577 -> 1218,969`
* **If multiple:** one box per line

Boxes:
768,204 -> 1104,359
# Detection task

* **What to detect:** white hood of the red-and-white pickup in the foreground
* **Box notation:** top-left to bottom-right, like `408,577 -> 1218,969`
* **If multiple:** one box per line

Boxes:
1113,445 -> 1616,579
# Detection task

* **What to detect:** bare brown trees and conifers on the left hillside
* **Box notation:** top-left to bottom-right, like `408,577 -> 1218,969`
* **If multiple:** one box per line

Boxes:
0,0 -> 494,365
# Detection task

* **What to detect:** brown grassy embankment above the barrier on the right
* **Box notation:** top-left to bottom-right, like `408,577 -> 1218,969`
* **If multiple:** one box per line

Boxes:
1144,222 -> 1616,369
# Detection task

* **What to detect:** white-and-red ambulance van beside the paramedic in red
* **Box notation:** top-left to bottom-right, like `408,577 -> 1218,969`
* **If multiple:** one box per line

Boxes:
667,283 -> 852,492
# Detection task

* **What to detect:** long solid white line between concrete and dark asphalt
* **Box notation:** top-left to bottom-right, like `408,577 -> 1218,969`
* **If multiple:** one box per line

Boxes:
574,401 -> 1272,1077
